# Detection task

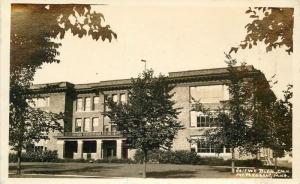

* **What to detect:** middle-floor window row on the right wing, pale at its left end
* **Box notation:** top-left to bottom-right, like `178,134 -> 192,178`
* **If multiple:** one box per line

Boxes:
191,111 -> 219,127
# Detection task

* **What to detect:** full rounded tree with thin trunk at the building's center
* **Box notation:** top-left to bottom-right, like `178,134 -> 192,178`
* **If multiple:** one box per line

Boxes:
105,70 -> 182,177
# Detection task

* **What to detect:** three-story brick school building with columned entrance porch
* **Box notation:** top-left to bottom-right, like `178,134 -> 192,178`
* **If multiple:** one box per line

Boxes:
32,66 -> 272,159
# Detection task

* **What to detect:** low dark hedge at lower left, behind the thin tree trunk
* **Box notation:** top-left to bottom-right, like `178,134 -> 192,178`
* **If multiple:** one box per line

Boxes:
9,150 -> 58,162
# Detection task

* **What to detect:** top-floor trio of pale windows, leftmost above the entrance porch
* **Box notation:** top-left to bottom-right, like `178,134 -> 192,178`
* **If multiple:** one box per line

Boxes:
76,96 -> 100,111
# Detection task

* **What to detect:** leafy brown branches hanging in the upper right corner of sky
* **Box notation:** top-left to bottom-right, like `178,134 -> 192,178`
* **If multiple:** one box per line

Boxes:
229,7 -> 294,54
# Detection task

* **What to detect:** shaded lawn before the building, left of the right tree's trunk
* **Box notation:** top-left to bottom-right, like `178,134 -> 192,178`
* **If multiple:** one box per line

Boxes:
9,162 -> 235,178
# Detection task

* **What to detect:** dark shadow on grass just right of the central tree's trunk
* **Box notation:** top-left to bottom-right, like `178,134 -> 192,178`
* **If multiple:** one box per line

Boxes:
147,170 -> 196,178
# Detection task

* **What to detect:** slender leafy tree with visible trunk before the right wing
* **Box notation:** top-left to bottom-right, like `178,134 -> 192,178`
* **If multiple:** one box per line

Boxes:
205,55 -> 253,173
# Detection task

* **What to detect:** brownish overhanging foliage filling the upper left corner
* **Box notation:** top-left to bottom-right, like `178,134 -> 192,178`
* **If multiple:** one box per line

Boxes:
11,4 -> 117,71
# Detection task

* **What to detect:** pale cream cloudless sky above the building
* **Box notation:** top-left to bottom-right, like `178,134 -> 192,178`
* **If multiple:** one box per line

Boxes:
34,5 -> 293,97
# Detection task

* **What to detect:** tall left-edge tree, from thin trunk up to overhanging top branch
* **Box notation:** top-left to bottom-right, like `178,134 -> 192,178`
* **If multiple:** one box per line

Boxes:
9,4 -> 117,173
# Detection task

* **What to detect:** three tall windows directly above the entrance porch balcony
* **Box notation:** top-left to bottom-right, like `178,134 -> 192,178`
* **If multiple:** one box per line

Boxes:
75,118 -> 99,132
